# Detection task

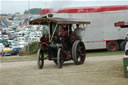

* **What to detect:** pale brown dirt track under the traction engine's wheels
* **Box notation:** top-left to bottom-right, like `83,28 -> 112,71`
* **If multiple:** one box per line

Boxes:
0,55 -> 128,85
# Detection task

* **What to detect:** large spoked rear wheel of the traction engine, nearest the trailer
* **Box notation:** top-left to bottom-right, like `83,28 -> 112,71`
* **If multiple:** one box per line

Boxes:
72,40 -> 86,65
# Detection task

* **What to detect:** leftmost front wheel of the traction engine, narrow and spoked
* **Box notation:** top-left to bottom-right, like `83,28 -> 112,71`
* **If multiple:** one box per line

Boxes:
37,48 -> 44,69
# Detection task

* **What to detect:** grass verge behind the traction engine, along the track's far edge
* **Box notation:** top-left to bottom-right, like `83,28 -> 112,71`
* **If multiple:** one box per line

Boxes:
0,50 -> 124,62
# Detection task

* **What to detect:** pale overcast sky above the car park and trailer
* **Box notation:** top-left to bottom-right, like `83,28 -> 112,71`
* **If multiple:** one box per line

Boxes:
0,0 -> 128,14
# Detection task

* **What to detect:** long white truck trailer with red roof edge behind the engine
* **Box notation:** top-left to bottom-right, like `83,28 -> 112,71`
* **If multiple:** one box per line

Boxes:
40,5 -> 128,51
